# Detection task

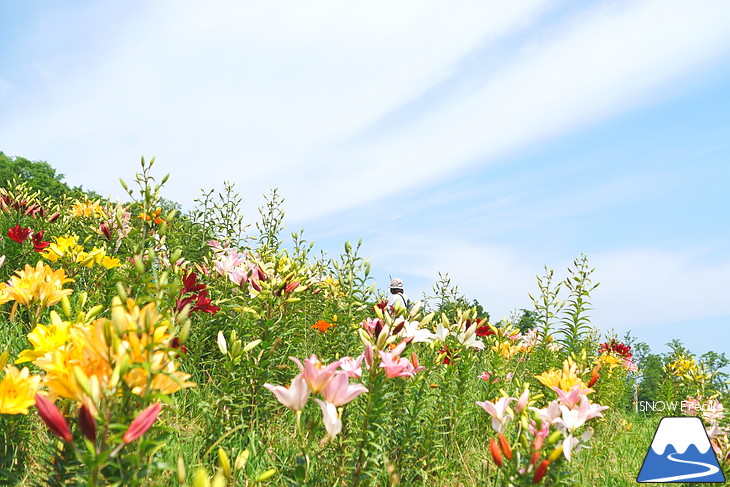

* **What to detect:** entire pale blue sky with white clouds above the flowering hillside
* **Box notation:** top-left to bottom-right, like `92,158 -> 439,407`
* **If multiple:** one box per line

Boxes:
0,0 -> 730,354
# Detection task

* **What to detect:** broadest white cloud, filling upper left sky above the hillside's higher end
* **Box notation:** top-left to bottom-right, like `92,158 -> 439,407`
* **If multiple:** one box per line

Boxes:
2,0 -> 552,206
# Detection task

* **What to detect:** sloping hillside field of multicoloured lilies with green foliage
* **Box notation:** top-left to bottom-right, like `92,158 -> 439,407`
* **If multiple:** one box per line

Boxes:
0,157 -> 730,487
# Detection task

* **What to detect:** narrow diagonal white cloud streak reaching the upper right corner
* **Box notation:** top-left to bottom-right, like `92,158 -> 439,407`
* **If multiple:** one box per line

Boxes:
310,0 -> 730,221
